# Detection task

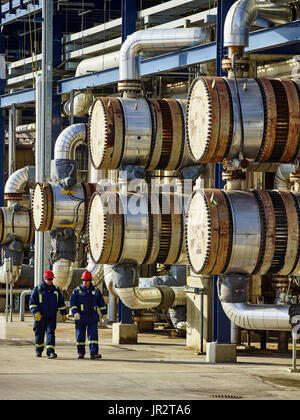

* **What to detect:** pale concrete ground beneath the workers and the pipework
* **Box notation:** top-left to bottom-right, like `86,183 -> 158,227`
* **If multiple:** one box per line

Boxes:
0,315 -> 300,402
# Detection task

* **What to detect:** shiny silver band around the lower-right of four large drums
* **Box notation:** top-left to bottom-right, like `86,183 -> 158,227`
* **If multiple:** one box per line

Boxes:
226,191 -> 261,273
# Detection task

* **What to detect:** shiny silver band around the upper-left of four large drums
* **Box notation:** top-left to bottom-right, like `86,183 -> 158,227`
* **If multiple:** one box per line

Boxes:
120,98 -> 152,167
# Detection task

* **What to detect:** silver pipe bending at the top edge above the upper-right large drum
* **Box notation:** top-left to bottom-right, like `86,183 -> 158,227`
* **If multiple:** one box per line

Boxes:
224,0 -> 293,50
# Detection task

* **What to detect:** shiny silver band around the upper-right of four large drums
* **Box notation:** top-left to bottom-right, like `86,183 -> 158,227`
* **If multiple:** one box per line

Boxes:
225,78 -> 264,159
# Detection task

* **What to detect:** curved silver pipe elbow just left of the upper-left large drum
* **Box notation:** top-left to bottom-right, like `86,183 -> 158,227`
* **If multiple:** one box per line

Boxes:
54,123 -> 86,160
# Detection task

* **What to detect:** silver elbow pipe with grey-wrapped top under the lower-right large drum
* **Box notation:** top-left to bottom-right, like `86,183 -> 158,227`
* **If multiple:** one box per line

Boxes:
218,274 -> 292,331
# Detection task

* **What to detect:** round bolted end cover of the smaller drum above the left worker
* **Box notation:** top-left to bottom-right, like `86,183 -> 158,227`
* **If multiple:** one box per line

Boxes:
32,182 -> 53,232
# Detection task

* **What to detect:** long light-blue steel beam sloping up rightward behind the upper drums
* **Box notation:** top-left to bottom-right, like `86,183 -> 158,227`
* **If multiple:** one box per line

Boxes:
0,19 -> 300,108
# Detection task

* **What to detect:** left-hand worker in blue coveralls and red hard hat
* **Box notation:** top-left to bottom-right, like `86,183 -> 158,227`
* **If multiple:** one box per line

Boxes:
29,270 -> 67,359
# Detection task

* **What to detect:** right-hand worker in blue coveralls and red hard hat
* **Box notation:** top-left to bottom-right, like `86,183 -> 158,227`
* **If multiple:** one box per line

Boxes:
70,271 -> 107,359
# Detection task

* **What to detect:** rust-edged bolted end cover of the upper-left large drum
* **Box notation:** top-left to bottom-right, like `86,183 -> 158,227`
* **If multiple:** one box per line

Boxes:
88,97 -> 124,169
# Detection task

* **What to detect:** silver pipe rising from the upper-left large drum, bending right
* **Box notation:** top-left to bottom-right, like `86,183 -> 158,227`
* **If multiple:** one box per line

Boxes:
119,28 -> 208,81
